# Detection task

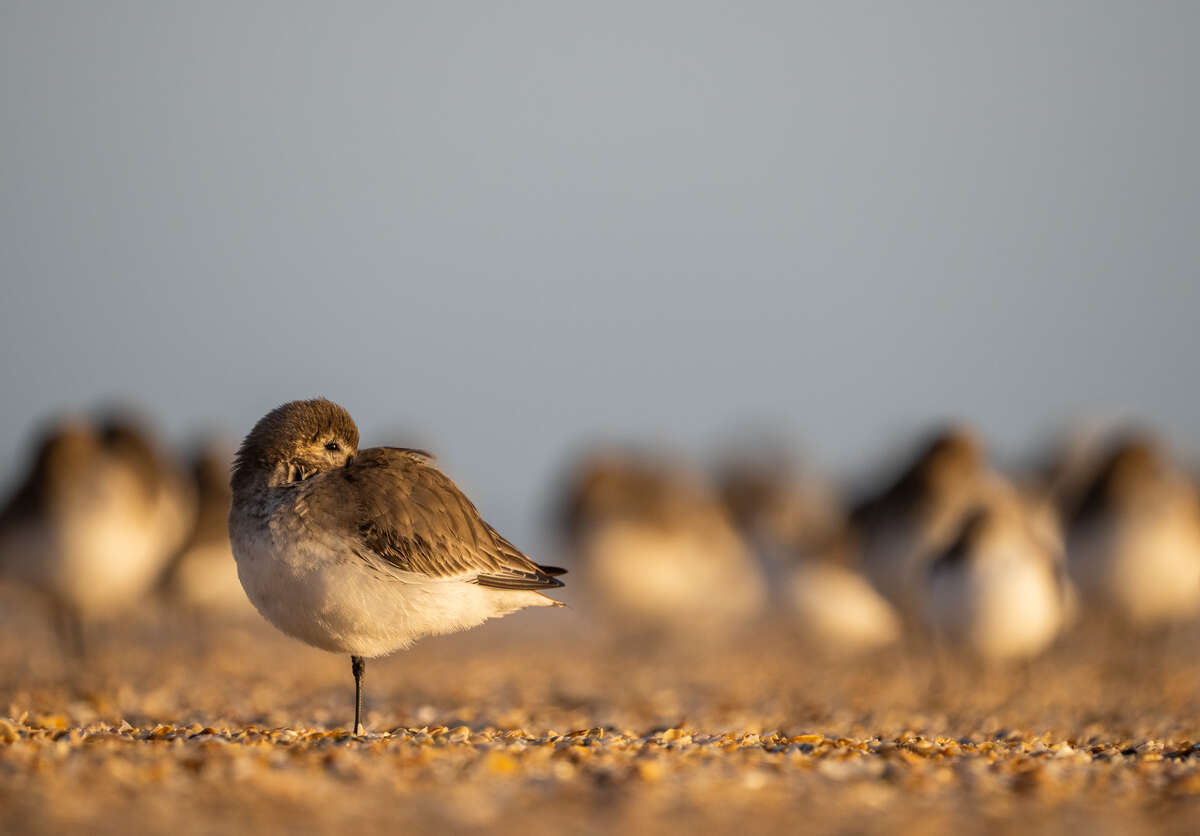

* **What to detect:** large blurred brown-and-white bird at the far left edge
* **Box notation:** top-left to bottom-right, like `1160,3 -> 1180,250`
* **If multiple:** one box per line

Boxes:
0,416 -> 190,656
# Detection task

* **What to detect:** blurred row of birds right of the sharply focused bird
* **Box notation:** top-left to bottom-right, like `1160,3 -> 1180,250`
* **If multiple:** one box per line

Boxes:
557,426 -> 1200,663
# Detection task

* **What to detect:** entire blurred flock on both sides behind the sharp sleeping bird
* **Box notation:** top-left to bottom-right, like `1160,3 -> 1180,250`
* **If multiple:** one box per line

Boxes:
0,407 -> 1200,662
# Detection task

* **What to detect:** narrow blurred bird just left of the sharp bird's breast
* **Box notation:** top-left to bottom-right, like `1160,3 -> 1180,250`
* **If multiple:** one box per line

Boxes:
163,438 -> 253,615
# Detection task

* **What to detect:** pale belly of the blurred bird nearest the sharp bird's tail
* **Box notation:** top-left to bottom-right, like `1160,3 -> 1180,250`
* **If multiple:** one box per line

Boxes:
580,521 -> 767,630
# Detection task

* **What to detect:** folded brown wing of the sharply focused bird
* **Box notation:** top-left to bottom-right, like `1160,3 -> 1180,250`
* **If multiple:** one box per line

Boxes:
302,447 -> 563,589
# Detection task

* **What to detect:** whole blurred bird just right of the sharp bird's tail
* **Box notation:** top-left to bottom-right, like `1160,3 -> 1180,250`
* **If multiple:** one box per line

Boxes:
557,446 -> 766,638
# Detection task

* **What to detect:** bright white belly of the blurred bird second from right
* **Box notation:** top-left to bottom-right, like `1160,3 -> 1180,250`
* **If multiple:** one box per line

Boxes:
924,547 -> 1064,661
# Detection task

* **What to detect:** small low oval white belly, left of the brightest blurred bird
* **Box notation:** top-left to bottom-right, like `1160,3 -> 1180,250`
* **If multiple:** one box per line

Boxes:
786,563 -> 900,652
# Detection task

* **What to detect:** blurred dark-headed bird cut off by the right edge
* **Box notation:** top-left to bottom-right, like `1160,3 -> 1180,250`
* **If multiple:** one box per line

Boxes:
1067,429 -> 1200,630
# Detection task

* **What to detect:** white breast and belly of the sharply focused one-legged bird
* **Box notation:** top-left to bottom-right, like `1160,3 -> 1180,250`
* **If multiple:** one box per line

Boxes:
230,498 -> 557,657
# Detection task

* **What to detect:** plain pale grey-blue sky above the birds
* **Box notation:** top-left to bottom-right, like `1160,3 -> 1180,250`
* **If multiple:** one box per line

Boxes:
0,0 -> 1200,537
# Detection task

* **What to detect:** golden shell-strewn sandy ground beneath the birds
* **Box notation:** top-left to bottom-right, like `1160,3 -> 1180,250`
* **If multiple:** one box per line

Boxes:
0,582 -> 1200,834
